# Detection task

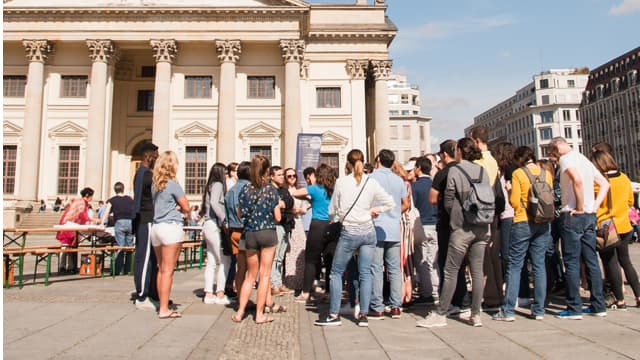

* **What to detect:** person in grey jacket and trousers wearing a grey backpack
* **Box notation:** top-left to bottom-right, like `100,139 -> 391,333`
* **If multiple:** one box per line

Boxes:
416,138 -> 495,328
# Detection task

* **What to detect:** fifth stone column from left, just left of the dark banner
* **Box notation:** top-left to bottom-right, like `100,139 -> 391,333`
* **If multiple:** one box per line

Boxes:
280,40 -> 305,168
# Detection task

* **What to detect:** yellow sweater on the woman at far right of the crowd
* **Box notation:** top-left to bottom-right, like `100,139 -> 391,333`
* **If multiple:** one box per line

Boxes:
595,173 -> 633,234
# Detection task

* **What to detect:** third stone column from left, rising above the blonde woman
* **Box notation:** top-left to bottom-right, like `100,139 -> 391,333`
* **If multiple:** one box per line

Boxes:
151,39 -> 178,151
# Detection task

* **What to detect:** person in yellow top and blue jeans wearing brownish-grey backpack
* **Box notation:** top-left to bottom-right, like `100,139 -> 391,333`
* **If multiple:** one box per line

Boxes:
493,146 -> 555,322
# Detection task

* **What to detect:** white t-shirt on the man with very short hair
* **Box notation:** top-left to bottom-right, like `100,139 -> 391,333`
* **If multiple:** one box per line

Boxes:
558,150 -> 598,214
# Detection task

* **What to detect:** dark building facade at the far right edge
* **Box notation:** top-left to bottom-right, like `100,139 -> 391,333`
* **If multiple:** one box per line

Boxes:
580,47 -> 640,181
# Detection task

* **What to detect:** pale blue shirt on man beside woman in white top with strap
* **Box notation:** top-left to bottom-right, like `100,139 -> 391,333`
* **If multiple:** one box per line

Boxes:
370,167 -> 409,242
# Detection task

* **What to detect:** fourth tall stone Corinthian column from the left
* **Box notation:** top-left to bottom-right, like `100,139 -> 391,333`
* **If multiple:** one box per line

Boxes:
216,40 -> 242,164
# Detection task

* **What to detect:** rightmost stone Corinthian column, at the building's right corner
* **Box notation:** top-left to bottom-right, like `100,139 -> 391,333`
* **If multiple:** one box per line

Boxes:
371,60 -> 392,153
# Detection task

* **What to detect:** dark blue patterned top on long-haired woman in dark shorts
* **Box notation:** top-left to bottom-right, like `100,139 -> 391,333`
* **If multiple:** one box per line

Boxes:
238,184 -> 280,232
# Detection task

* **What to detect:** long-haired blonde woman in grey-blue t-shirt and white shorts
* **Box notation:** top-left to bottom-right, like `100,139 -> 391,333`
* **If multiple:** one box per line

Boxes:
150,151 -> 191,319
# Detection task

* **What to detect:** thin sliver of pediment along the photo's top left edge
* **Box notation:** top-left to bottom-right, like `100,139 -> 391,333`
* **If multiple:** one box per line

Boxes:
4,0 -> 310,9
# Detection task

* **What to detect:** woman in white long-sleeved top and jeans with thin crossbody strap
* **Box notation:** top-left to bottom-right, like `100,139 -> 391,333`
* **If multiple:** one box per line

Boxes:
315,149 -> 396,327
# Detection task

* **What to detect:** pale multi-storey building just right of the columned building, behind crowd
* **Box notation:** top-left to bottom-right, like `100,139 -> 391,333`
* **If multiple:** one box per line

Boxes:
387,74 -> 431,163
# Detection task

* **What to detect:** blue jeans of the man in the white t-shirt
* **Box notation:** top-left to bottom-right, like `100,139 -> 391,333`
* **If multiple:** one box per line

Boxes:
560,212 -> 606,314
